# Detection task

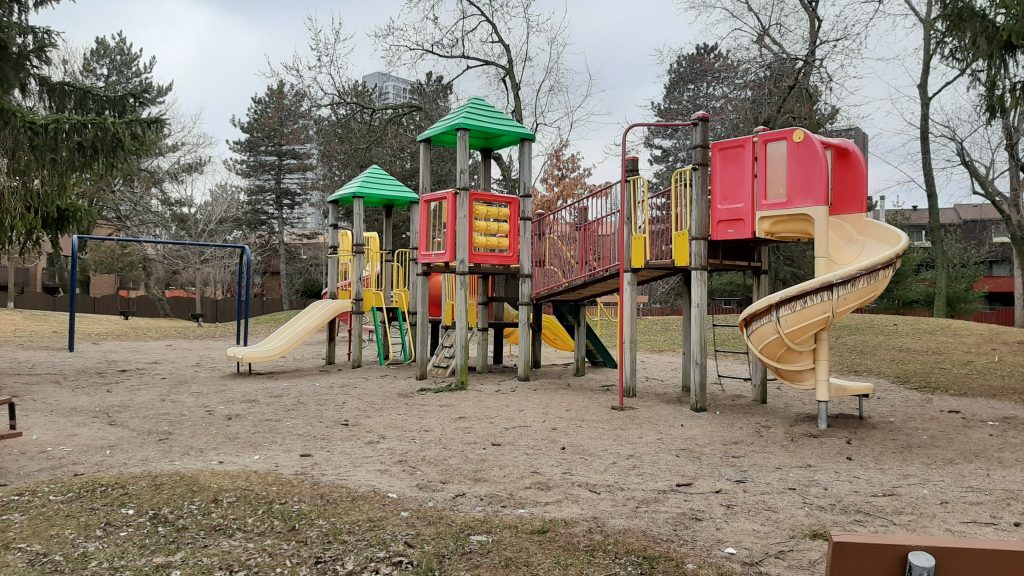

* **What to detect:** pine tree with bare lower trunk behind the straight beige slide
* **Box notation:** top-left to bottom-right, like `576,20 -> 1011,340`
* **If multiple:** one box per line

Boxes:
227,81 -> 314,310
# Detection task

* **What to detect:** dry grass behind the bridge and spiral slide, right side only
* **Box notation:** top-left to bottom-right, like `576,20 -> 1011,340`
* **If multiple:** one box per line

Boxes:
600,315 -> 1024,404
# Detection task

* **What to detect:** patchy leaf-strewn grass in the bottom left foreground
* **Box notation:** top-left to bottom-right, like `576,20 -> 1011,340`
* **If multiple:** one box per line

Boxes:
0,472 -> 735,576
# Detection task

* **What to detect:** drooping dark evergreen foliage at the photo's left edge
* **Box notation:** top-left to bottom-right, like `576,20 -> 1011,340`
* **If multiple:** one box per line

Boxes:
0,0 -> 165,250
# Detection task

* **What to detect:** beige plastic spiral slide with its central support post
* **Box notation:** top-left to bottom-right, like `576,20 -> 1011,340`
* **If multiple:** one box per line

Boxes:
739,207 -> 910,428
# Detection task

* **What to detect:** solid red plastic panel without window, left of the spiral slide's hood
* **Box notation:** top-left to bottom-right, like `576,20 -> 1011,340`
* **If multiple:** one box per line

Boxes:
711,136 -> 754,240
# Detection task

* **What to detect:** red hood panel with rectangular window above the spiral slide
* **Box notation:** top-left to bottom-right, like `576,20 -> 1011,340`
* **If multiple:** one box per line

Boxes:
757,128 -> 828,211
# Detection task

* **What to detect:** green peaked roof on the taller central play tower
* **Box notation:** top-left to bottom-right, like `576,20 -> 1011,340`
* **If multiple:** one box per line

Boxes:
416,97 -> 537,150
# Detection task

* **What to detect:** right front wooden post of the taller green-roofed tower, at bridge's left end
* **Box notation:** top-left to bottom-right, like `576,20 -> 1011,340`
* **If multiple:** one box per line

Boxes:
516,139 -> 534,381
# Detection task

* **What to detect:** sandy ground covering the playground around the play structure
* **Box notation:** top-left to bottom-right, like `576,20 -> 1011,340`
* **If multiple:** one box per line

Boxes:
0,327 -> 1024,575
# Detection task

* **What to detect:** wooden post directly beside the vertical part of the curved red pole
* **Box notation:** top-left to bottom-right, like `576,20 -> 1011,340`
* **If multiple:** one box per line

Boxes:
618,156 -> 640,398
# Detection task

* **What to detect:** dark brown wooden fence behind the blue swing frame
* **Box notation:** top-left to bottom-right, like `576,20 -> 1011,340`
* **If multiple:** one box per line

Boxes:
0,292 -> 315,323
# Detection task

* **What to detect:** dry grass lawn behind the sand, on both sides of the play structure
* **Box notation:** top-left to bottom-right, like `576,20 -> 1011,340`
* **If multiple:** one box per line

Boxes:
8,310 -> 1024,404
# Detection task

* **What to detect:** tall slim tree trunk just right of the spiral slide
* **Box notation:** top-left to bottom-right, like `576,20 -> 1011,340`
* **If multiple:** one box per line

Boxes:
918,0 -> 949,318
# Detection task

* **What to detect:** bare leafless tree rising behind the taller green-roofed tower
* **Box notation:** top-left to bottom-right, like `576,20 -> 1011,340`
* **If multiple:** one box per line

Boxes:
373,0 -> 595,181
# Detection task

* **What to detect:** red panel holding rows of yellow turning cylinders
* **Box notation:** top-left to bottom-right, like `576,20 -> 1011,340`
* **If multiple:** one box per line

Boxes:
469,191 -> 519,264
